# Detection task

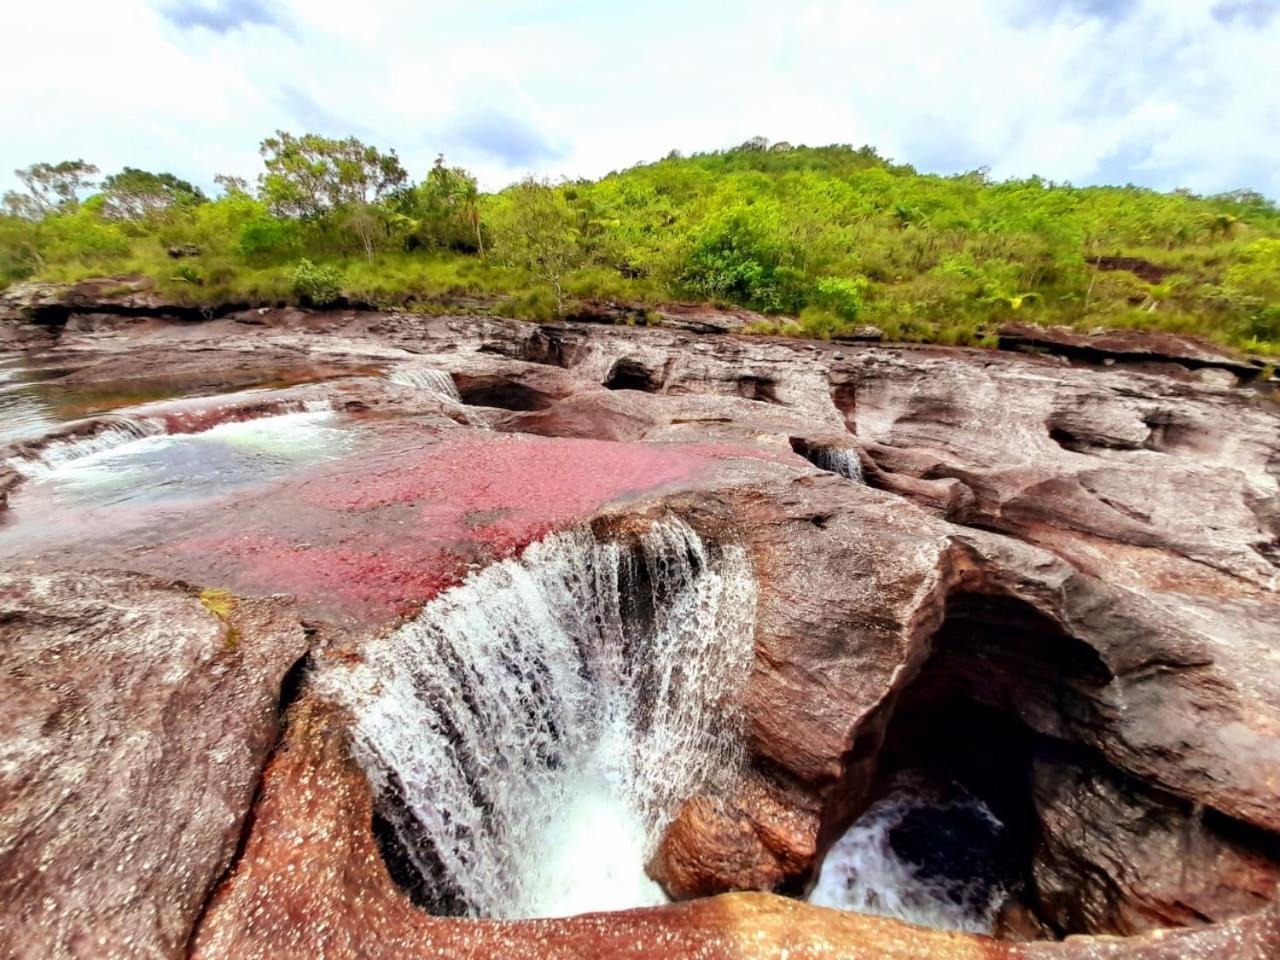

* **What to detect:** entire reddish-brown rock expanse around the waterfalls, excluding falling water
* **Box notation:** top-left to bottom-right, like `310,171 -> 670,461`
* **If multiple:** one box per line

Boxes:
0,291 -> 1280,959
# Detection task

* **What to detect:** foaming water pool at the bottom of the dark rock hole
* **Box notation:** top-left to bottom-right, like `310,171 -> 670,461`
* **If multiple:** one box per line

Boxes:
809,774 -> 1014,933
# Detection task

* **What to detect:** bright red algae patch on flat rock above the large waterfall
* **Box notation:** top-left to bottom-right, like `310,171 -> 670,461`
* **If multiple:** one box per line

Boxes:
158,434 -> 757,620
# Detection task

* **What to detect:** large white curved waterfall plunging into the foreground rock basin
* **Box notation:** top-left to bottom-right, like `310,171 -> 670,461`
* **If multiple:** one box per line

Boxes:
317,517 -> 755,918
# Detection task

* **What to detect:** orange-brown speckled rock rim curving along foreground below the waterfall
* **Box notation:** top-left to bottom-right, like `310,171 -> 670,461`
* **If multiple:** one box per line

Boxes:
192,701 -> 1280,960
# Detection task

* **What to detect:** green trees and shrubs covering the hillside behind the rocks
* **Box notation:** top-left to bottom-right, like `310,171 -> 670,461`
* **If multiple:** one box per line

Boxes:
0,133 -> 1280,353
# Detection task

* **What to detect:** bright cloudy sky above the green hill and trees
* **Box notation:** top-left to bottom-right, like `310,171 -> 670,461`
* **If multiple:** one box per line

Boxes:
0,0 -> 1280,198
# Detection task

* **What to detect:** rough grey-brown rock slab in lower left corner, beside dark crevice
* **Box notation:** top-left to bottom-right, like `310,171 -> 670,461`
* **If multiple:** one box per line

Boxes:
0,571 -> 306,957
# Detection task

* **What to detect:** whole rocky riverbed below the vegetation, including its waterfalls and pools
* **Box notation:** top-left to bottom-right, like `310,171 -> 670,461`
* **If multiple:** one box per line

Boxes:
0,283 -> 1280,960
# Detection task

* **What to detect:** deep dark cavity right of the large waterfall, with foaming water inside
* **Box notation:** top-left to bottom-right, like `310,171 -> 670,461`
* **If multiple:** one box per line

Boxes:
812,594 -> 1111,933
